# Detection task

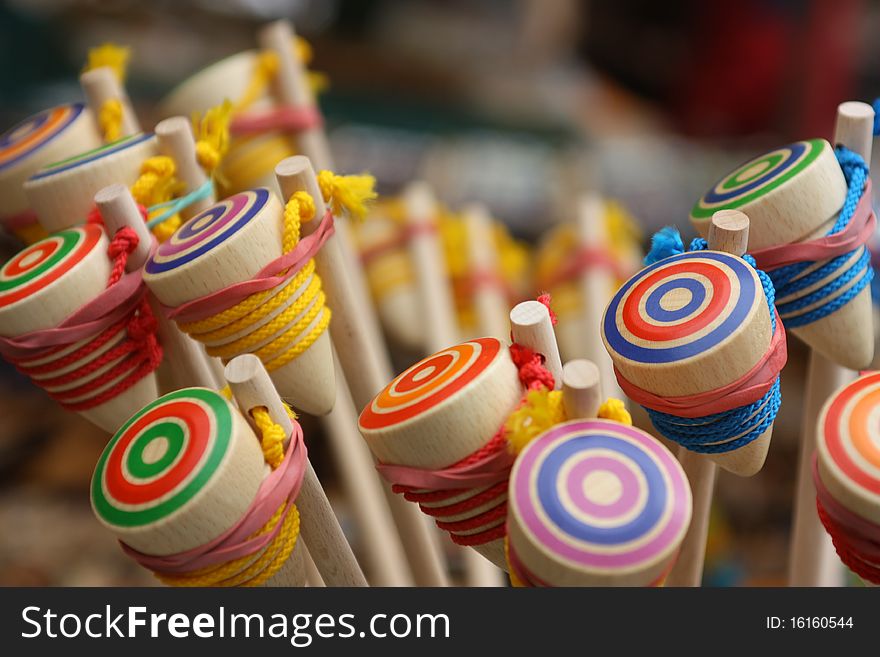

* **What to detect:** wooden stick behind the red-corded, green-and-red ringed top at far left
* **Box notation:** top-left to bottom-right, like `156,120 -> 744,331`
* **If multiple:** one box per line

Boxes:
95,184 -> 218,392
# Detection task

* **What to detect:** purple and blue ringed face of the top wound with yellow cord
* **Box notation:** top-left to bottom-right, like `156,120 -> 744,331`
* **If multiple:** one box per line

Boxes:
146,187 -> 270,274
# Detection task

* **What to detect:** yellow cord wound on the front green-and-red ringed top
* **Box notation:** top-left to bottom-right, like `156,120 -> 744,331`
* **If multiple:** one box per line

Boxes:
156,404 -> 300,587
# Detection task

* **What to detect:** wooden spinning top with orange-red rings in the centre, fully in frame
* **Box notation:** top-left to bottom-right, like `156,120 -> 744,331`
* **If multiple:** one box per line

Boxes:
358,338 -> 523,568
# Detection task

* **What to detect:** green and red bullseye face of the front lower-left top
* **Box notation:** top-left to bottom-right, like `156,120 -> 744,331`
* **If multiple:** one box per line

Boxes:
92,388 -> 232,528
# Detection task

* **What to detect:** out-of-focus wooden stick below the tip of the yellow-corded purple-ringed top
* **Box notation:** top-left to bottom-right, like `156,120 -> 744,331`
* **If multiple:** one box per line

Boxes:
321,359 -> 413,586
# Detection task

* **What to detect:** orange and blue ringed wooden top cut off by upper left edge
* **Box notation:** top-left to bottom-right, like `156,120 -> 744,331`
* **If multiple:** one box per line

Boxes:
0,103 -> 101,244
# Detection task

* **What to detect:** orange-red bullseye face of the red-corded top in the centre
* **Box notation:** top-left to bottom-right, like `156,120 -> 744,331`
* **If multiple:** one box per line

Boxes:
359,338 -> 509,429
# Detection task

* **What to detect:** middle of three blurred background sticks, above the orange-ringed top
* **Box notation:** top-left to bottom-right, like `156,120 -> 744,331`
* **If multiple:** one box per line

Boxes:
464,204 -> 510,341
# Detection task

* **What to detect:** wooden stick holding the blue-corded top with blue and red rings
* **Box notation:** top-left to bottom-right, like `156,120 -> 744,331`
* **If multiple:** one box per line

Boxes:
666,210 -> 749,586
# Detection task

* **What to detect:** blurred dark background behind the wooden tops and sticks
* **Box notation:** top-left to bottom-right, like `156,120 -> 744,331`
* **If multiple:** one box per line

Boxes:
0,0 -> 880,586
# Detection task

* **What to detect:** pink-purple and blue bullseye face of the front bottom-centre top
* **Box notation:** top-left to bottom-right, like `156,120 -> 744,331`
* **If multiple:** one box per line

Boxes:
508,420 -> 691,572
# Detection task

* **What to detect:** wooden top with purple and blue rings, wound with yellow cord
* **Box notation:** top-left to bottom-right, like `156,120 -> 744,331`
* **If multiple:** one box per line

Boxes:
144,187 -> 336,415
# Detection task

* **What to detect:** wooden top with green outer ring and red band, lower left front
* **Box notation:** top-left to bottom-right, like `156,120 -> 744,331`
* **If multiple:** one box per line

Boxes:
91,388 -> 304,586
